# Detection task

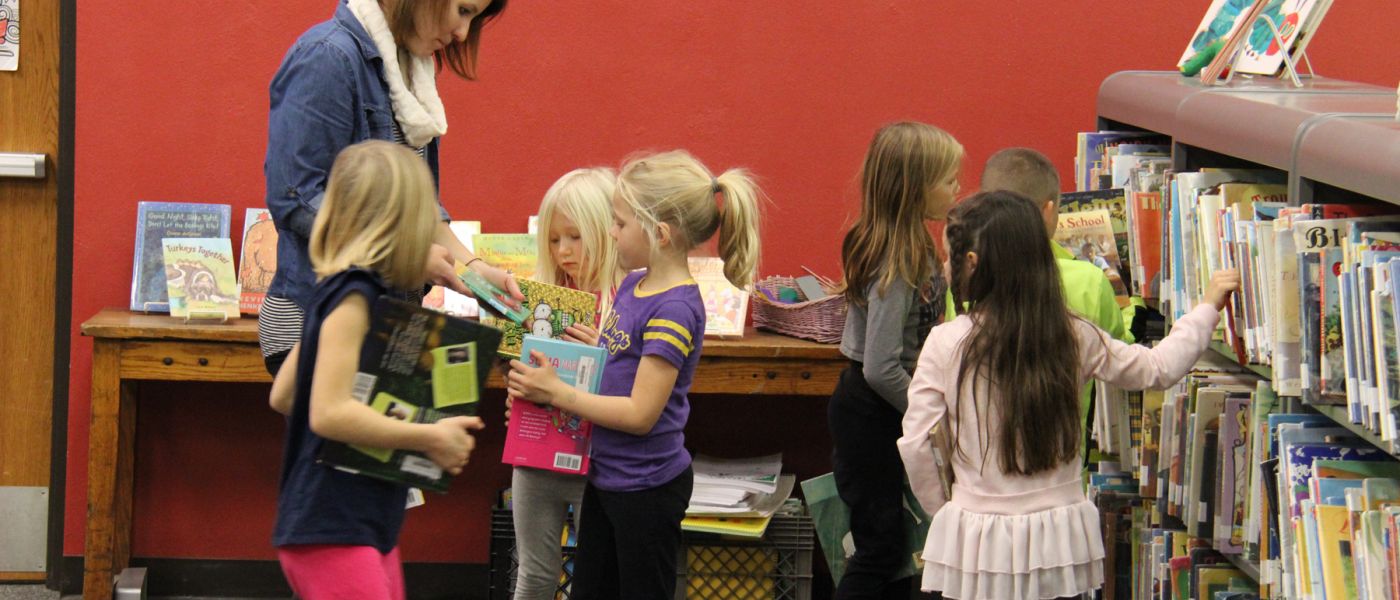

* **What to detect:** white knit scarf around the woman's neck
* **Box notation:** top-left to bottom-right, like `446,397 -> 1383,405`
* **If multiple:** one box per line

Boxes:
350,0 -> 447,148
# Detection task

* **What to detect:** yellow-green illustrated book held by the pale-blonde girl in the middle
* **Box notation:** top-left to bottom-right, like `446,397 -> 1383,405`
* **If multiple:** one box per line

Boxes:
482,280 -> 598,358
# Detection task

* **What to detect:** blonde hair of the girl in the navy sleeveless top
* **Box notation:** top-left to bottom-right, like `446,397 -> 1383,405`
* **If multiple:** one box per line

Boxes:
309,140 -> 440,290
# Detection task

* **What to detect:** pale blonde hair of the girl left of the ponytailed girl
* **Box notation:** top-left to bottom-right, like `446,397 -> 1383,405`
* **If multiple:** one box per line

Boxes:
535,166 -> 623,310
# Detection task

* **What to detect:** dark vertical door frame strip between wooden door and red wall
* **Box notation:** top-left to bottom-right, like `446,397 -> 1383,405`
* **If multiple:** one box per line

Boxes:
45,0 -> 78,590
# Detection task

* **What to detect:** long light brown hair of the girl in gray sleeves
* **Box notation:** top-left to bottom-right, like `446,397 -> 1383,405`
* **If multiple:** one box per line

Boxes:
841,122 -> 963,305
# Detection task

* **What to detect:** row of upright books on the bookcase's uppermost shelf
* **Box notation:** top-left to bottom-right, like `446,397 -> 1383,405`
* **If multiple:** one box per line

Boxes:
1061,131 -> 1400,442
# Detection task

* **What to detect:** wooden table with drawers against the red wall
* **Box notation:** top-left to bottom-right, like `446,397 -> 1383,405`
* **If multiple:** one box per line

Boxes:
83,309 -> 846,600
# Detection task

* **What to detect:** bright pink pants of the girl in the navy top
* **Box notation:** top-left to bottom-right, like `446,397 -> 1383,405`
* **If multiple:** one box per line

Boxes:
277,545 -> 403,600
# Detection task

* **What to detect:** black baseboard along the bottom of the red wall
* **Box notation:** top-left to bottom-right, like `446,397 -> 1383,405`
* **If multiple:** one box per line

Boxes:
59,557 -> 490,600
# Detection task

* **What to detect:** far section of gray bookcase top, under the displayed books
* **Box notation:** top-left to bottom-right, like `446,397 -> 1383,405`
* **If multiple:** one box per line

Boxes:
1173,90 -> 1396,171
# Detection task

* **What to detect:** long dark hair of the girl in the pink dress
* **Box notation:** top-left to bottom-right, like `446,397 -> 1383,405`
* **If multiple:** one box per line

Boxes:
946,192 -> 1084,476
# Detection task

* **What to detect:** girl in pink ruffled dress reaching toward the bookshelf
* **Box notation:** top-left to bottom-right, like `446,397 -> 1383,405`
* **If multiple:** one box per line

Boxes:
899,192 -> 1239,600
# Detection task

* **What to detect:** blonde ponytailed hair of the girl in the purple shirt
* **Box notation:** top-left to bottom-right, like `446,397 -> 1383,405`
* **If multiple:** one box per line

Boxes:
617,150 -> 762,290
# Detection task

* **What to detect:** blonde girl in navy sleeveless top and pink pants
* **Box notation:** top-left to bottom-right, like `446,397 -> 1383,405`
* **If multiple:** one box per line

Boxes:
270,141 -> 482,600
